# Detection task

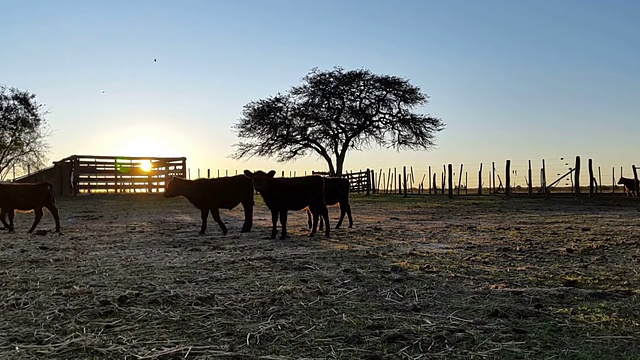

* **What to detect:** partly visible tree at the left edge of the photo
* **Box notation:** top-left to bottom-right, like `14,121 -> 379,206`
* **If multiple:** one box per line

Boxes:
0,85 -> 49,179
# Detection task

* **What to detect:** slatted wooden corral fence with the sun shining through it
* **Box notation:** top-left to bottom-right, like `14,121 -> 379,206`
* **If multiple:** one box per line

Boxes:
16,155 -> 187,195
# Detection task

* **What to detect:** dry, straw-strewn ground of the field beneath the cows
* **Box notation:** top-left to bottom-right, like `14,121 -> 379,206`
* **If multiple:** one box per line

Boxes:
0,195 -> 640,359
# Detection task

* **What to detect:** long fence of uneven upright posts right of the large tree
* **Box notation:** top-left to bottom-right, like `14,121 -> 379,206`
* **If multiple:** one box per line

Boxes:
371,156 -> 638,198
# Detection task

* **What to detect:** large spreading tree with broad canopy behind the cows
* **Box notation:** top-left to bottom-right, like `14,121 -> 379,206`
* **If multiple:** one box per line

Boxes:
232,67 -> 444,176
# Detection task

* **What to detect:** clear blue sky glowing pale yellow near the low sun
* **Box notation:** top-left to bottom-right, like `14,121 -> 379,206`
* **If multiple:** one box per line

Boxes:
0,0 -> 640,188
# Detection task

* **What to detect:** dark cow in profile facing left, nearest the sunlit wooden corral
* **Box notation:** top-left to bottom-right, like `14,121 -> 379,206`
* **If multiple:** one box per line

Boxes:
164,175 -> 254,235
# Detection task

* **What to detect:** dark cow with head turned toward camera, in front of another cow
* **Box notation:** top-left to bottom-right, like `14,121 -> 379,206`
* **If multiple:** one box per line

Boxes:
244,170 -> 329,239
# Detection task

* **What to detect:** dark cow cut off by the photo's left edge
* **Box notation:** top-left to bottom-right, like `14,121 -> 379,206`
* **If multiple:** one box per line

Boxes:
0,182 -> 60,233
